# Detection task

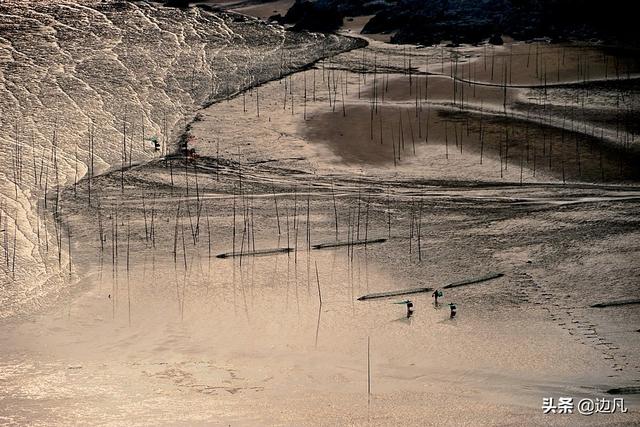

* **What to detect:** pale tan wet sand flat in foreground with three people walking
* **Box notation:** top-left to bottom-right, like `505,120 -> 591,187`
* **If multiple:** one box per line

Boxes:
2,162 -> 640,425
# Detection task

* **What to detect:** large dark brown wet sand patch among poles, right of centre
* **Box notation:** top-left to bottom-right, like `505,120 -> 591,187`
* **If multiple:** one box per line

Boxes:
305,106 -> 640,182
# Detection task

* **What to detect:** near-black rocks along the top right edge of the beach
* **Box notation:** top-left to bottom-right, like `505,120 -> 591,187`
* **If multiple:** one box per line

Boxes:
283,0 -> 640,45
